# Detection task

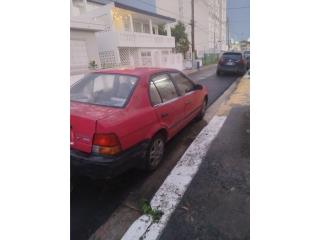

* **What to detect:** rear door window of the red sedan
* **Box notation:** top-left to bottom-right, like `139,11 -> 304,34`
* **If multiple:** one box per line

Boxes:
152,74 -> 178,102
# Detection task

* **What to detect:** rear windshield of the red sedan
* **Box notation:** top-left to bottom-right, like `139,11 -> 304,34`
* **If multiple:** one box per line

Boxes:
70,73 -> 137,107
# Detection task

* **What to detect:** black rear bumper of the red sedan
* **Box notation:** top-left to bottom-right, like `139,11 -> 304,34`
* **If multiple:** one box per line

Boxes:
70,141 -> 149,178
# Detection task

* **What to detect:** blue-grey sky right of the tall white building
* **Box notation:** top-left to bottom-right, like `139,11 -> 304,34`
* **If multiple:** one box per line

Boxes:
227,0 -> 250,41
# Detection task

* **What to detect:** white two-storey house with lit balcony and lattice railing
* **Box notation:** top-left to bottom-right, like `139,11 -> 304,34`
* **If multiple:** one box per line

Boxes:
71,0 -> 183,76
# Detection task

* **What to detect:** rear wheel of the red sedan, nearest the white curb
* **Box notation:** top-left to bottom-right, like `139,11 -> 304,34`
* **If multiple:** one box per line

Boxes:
144,133 -> 165,171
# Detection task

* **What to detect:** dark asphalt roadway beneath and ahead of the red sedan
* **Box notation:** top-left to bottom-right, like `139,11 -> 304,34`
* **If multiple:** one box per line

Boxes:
70,67 -> 238,240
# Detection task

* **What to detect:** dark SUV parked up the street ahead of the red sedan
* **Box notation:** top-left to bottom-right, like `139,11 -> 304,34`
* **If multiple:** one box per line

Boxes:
216,52 -> 247,76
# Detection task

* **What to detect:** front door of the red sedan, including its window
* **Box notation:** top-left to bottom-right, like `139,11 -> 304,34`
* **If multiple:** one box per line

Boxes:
170,72 -> 202,124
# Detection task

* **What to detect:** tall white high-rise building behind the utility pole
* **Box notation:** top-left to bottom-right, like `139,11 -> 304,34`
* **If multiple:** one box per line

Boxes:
156,0 -> 228,57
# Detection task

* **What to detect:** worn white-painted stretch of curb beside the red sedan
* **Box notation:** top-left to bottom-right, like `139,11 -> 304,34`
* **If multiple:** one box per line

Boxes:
122,116 -> 226,240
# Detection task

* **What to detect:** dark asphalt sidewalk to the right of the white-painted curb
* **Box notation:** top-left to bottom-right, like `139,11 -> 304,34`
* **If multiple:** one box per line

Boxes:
160,106 -> 250,240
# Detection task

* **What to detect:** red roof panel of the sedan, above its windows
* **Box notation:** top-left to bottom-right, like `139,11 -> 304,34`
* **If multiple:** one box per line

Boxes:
95,67 -> 178,77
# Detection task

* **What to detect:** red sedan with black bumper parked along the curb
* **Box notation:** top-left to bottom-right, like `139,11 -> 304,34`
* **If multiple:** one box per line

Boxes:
70,68 -> 208,178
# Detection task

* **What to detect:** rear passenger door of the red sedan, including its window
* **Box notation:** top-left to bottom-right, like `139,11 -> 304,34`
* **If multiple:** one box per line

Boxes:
150,73 -> 184,138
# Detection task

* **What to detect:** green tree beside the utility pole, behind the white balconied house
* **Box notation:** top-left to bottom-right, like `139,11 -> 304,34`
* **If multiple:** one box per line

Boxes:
171,22 -> 190,57
